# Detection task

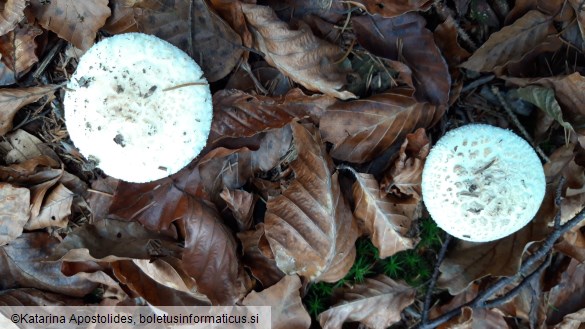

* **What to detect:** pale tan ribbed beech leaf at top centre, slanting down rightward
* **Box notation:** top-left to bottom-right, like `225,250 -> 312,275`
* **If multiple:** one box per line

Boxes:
242,4 -> 356,99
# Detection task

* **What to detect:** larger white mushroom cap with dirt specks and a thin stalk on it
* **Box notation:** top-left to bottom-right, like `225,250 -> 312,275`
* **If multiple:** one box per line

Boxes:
64,33 -> 213,183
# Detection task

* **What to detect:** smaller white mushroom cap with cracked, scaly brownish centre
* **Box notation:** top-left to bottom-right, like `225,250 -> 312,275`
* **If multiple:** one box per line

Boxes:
422,124 -> 546,242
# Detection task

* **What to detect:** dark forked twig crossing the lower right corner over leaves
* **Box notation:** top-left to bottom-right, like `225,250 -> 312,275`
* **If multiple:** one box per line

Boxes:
417,181 -> 585,329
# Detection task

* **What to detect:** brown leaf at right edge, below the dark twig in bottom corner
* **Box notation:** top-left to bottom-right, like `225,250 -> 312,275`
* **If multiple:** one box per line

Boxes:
546,259 -> 585,324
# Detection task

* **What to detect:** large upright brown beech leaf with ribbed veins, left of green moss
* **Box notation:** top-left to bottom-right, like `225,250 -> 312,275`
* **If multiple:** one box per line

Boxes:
264,123 -> 357,282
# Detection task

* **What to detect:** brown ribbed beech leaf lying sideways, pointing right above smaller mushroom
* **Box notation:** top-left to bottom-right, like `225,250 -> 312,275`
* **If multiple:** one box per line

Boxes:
319,89 -> 445,163
